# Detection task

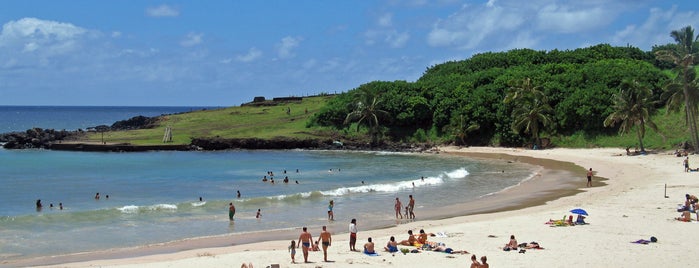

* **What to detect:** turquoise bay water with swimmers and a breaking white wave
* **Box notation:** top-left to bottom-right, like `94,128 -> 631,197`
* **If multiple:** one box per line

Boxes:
0,107 -> 538,260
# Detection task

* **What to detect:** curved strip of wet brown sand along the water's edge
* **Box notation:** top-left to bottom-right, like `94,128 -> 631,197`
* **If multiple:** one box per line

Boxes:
3,148 -> 584,266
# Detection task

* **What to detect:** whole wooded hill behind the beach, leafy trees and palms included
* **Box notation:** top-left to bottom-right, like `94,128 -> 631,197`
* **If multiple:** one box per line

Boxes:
308,26 -> 698,151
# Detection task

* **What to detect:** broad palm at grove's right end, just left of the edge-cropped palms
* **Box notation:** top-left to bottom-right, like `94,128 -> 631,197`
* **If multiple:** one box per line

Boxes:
604,80 -> 665,152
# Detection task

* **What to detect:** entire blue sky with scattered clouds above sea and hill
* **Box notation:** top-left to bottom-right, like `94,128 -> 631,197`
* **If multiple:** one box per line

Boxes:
0,0 -> 699,106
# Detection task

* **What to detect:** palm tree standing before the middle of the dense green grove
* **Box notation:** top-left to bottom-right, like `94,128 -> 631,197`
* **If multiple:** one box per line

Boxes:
503,78 -> 553,147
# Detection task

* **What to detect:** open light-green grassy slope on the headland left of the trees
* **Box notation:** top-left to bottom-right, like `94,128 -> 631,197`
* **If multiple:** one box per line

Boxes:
87,97 -> 332,145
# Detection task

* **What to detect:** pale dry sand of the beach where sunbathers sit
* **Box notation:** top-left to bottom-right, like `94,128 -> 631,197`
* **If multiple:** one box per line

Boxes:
19,147 -> 699,267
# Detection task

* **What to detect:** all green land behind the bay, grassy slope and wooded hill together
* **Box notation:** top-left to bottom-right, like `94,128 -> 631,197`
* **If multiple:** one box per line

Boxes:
90,27 -> 699,150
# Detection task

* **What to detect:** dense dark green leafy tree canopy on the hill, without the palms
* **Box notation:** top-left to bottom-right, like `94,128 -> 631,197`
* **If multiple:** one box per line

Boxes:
310,44 -> 673,146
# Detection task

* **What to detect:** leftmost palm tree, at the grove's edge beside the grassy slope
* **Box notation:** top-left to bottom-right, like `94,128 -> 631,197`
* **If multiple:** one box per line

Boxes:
345,87 -> 389,145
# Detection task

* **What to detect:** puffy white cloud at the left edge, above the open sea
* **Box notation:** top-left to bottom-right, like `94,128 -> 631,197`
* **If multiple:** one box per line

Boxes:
0,18 -> 88,56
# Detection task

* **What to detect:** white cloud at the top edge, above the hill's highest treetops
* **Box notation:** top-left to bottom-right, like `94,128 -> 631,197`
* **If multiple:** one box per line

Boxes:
536,4 -> 617,33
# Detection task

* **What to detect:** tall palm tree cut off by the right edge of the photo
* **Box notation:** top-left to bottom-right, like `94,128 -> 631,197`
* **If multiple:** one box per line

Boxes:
656,26 -> 699,151
